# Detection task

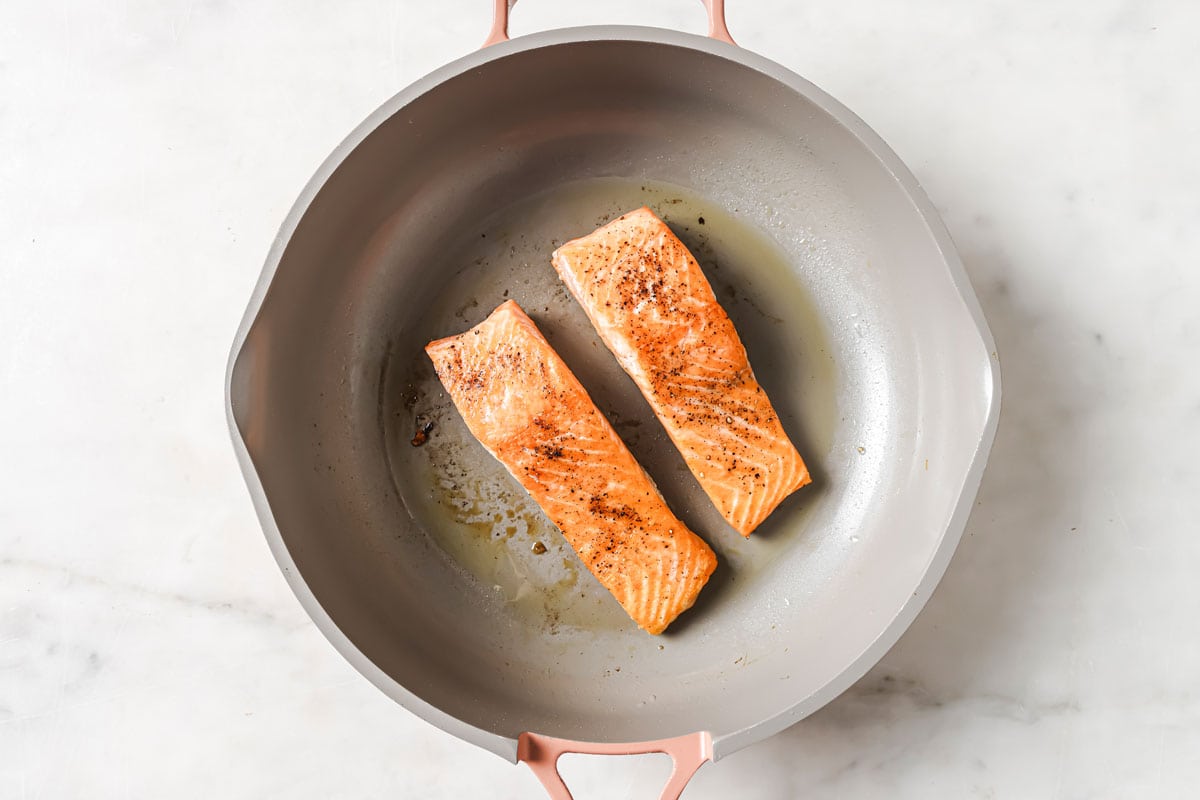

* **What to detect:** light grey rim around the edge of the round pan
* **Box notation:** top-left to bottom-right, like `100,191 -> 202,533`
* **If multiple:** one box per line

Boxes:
224,25 -> 1001,762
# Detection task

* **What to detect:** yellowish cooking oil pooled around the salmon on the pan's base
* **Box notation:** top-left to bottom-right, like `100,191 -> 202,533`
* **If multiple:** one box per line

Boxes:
385,179 -> 835,632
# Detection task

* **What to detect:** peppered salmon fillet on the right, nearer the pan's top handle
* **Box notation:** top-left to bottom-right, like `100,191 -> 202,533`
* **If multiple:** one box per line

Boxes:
553,207 -> 811,536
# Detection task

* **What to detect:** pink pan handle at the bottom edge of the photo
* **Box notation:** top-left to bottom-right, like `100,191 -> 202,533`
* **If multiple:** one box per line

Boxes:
516,734 -> 713,800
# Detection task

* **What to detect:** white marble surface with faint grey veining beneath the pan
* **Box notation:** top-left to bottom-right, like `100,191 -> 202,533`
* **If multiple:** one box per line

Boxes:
0,0 -> 1200,800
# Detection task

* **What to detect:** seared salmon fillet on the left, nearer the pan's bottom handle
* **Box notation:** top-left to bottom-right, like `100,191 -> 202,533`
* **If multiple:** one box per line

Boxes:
425,300 -> 716,633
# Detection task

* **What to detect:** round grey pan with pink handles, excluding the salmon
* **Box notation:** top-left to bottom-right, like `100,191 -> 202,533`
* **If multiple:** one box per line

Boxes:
227,0 -> 1000,798
